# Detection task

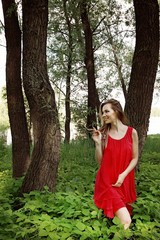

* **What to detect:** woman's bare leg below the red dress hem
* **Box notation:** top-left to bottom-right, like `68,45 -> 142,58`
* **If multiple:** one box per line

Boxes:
115,207 -> 132,230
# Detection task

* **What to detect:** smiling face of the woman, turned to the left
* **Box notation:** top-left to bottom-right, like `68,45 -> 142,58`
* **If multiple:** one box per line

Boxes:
102,103 -> 117,124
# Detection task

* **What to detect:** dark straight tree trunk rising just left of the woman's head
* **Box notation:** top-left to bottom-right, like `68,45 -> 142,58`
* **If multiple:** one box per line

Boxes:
80,1 -> 97,128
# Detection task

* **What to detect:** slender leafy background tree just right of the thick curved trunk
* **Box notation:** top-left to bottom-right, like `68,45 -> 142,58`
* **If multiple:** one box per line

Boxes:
48,0 -> 84,142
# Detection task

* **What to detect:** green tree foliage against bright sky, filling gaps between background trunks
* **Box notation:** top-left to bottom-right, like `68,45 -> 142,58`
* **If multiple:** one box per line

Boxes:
48,0 -> 135,130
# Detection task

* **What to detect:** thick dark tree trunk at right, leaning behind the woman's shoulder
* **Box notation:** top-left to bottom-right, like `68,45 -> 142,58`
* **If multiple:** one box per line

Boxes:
125,0 -> 159,159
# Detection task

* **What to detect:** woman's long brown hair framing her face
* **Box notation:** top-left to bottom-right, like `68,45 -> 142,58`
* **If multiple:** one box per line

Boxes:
99,98 -> 129,132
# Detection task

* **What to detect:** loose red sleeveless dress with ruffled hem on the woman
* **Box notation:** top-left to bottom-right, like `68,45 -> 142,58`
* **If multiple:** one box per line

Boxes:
94,127 -> 136,218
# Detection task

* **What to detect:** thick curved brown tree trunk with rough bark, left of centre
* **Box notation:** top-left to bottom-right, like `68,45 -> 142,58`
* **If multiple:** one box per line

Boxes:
21,0 -> 60,192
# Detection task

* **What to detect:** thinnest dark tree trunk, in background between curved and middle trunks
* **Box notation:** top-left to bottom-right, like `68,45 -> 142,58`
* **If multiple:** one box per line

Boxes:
63,0 -> 73,143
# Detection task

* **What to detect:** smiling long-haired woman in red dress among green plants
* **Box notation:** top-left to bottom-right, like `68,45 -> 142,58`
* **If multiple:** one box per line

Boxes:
92,99 -> 138,229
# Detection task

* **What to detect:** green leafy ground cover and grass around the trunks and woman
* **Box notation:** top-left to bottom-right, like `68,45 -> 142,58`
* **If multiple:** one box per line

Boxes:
0,135 -> 160,240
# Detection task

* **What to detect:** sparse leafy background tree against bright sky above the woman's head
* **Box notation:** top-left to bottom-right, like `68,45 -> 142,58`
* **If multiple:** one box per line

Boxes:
95,1 -> 135,99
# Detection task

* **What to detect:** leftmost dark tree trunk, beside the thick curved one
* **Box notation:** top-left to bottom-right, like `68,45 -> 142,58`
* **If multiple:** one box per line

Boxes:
2,0 -> 30,178
